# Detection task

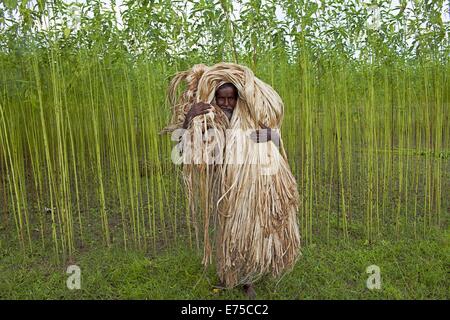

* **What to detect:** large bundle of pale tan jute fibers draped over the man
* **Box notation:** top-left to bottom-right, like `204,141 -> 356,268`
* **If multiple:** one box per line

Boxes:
163,63 -> 300,287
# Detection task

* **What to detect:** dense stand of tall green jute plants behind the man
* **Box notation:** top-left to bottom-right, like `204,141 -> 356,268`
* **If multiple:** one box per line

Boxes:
0,0 -> 450,255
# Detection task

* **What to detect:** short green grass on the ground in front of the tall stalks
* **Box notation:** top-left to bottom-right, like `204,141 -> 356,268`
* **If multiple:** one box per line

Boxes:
0,232 -> 450,299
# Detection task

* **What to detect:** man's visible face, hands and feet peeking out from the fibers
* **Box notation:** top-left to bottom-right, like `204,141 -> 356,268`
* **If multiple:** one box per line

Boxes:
179,83 -> 279,299
